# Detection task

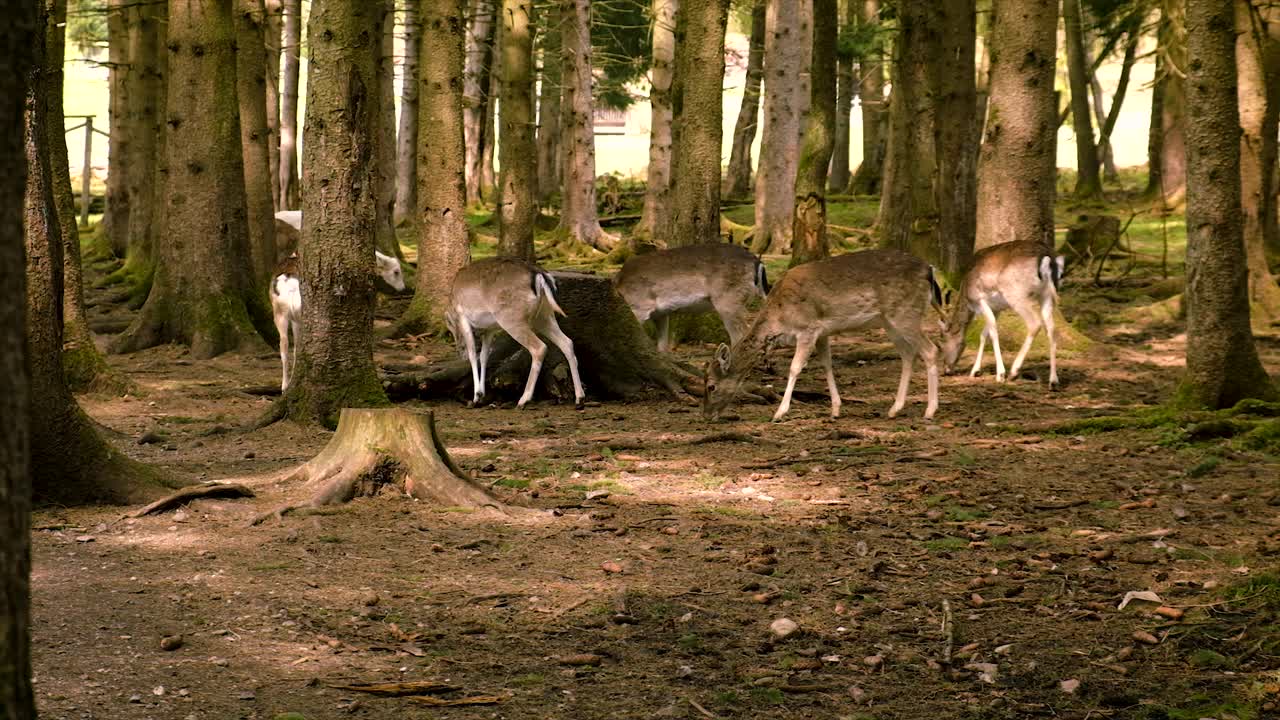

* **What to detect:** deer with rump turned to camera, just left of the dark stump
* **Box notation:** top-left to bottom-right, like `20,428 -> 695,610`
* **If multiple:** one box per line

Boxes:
444,258 -> 584,407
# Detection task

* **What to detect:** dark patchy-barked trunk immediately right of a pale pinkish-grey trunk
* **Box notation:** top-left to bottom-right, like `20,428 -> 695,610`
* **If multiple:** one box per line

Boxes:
791,0 -> 837,266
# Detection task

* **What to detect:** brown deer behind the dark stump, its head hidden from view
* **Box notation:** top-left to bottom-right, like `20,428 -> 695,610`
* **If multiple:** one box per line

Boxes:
613,243 -> 769,352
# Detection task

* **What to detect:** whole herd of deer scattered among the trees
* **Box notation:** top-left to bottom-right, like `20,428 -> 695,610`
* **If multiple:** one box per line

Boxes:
270,211 -> 1064,420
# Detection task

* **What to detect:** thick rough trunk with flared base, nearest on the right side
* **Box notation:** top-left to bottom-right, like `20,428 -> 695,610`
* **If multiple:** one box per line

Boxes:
1182,0 -> 1276,409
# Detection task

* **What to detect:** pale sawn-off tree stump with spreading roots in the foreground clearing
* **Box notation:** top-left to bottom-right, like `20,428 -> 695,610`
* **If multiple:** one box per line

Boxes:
252,407 -> 516,525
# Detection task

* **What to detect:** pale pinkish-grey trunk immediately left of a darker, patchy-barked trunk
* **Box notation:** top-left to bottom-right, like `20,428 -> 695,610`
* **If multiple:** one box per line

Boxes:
751,0 -> 813,255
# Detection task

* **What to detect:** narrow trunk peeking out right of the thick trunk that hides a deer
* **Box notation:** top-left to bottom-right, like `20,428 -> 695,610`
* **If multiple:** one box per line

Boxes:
373,0 -> 402,258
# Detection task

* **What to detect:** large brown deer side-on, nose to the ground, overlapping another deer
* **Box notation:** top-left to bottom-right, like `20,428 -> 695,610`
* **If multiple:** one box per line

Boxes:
703,250 -> 942,420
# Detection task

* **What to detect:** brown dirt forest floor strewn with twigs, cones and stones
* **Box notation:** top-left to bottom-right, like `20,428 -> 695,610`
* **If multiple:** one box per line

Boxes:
32,197 -> 1280,720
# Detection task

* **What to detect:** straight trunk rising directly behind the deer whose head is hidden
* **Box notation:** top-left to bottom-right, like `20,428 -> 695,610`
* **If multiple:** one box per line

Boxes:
659,0 -> 728,247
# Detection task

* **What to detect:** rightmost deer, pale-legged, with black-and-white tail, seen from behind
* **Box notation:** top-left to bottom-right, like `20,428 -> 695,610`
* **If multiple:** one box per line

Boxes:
942,241 -> 1065,387
